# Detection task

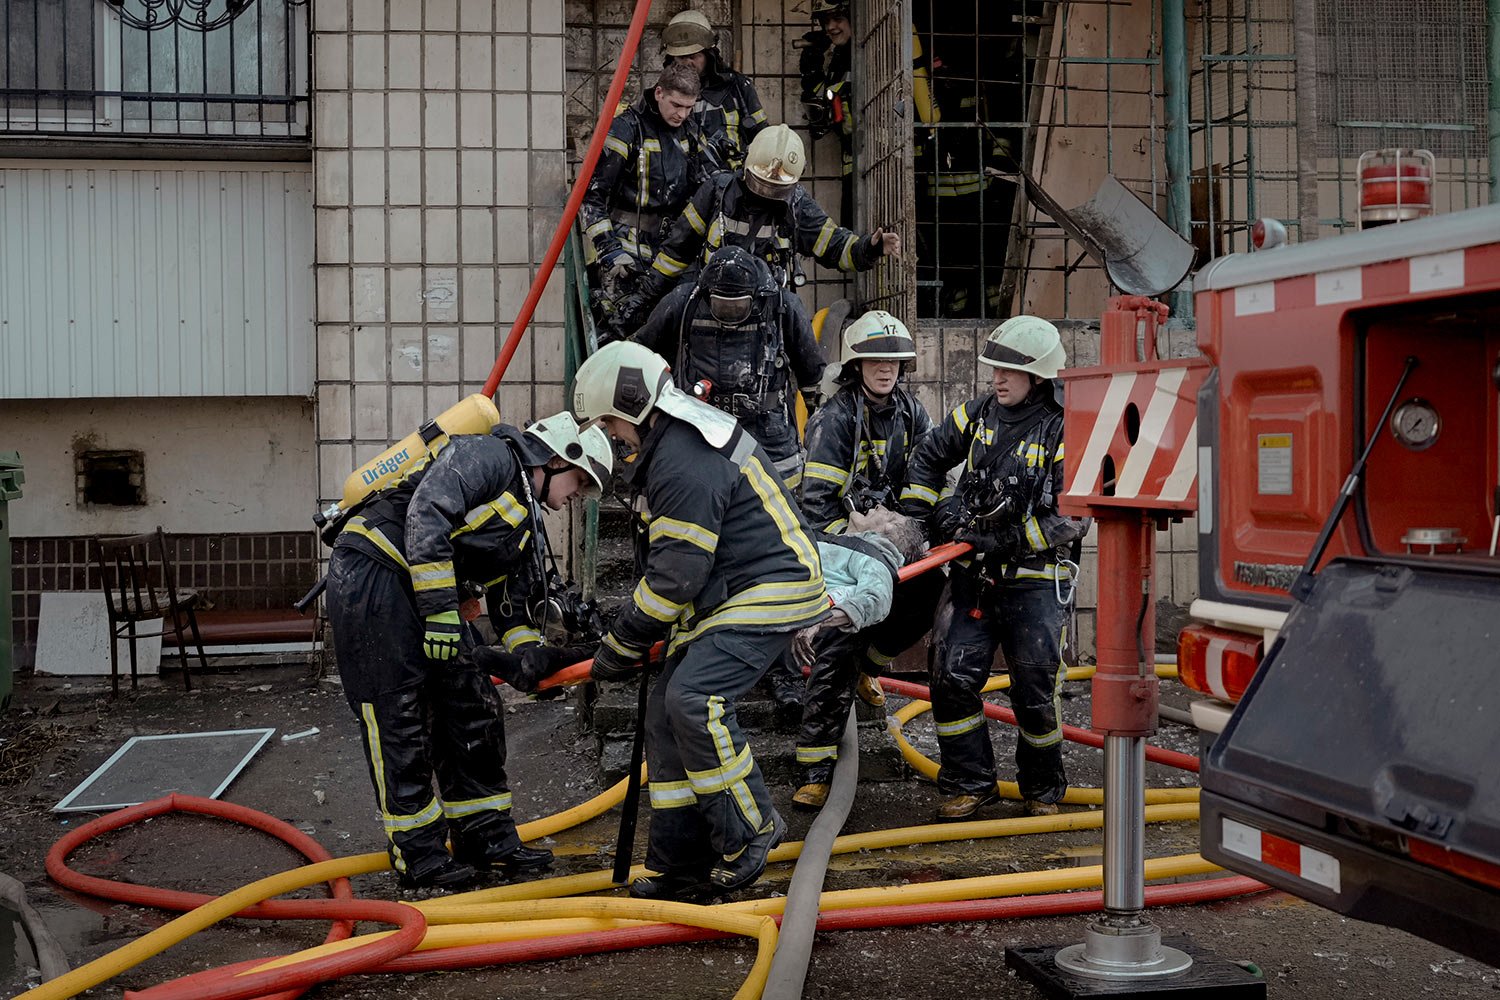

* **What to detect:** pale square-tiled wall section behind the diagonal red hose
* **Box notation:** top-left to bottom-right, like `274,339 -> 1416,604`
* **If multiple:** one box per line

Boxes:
312,0 -> 567,563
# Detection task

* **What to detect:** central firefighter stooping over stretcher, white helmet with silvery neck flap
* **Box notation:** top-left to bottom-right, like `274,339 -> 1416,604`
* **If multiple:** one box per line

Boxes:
573,343 -> 828,900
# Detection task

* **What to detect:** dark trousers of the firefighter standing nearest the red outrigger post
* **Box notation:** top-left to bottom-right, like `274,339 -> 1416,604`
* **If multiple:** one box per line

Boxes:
932,574 -> 1068,802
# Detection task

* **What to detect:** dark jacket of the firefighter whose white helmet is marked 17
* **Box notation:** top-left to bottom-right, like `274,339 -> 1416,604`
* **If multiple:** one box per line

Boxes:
801,384 -> 933,534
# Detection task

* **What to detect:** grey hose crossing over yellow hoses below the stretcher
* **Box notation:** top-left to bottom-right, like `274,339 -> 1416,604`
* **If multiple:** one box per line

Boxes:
761,705 -> 860,1000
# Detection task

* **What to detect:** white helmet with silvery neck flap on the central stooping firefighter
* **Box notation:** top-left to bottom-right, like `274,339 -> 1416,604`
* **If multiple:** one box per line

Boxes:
573,340 -> 740,448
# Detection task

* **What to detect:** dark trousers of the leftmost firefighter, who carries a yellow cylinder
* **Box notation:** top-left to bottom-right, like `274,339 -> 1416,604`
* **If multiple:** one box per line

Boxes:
327,547 -> 521,871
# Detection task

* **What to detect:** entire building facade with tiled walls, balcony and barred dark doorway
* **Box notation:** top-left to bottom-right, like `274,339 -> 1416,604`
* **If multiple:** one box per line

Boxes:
0,0 -> 1496,664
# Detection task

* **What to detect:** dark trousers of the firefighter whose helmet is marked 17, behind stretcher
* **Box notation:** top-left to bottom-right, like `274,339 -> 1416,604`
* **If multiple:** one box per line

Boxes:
797,571 -> 947,783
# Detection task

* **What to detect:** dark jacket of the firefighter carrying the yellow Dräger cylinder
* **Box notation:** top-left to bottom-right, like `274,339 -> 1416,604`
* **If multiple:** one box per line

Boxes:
333,426 -> 546,651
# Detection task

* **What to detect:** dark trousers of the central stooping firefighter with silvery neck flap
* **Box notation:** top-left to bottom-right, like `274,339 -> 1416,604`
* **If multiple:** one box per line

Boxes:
647,628 -> 792,877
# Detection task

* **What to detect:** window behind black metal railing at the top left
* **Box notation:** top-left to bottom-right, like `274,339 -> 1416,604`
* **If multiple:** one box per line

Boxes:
0,0 -> 309,145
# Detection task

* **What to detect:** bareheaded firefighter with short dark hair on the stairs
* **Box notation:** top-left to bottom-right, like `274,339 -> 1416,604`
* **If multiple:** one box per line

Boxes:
579,64 -> 716,326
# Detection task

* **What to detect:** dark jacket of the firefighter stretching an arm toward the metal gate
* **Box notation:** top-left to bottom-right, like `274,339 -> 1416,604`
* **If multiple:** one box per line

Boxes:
627,171 -> 884,319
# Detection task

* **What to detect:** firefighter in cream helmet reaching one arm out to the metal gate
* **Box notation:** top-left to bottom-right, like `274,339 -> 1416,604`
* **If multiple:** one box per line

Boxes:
615,124 -> 902,333
